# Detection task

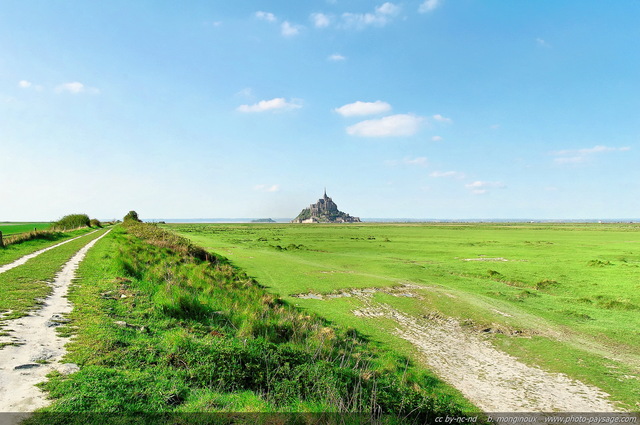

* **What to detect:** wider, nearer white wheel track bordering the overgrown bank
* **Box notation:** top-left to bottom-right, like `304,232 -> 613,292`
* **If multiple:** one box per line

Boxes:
0,230 -> 111,412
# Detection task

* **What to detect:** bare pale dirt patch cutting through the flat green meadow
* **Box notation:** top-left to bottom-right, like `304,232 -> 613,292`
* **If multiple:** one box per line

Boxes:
299,286 -> 618,412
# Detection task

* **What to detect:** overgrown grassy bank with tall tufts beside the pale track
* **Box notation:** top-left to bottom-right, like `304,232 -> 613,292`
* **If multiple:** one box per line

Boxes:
36,221 -> 473,423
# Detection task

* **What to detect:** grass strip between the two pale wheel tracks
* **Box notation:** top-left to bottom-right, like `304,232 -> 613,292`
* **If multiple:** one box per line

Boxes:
0,231 -> 109,332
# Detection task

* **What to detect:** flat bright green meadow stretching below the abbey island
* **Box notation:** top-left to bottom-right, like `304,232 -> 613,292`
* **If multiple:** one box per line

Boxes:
171,224 -> 640,409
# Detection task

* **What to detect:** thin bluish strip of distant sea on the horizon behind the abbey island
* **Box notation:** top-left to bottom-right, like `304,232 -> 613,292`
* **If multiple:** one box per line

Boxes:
142,217 -> 640,223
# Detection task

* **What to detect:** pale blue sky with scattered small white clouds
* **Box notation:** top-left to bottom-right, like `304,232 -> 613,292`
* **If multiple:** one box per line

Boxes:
0,0 -> 640,221
